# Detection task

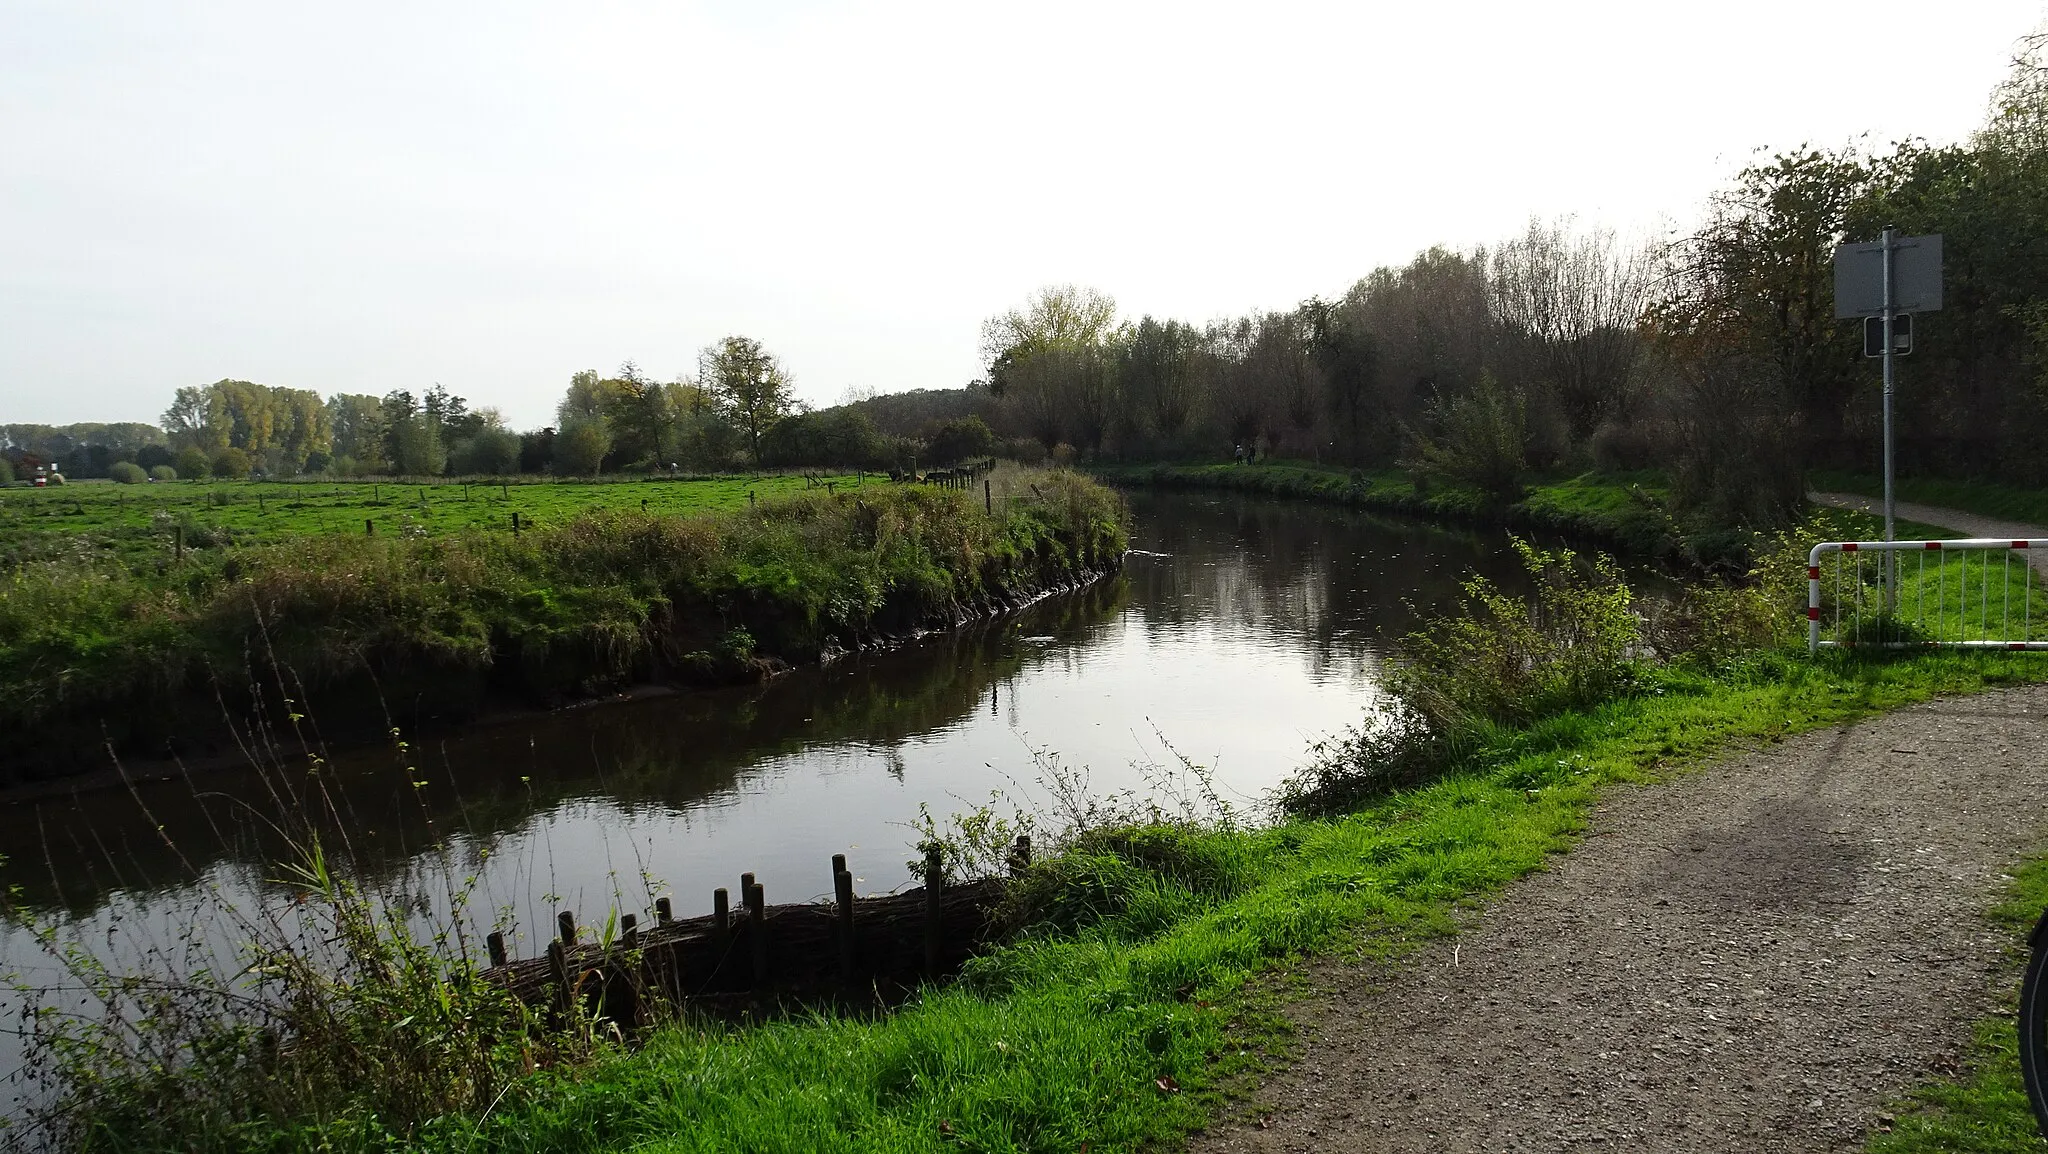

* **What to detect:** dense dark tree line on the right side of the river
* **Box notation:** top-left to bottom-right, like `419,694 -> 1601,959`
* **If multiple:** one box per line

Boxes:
954,35 -> 2048,523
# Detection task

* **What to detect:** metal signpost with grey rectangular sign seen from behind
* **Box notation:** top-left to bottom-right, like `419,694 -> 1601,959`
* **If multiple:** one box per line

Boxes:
1835,230 -> 1942,609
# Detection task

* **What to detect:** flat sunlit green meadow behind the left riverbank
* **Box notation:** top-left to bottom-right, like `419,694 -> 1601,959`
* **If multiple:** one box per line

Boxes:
0,473 -> 872,572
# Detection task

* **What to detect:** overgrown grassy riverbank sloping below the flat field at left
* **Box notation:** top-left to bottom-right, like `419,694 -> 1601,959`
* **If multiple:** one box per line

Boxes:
0,473 -> 1126,777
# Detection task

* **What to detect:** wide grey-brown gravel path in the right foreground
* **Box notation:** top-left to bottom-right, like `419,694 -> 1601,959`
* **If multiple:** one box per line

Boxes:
1192,687 -> 2048,1154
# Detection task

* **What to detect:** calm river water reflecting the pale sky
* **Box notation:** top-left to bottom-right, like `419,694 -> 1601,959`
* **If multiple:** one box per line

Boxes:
0,492 -> 1518,1097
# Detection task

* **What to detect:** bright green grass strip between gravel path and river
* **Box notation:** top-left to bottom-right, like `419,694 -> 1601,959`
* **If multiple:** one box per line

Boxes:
364,654 -> 2048,1152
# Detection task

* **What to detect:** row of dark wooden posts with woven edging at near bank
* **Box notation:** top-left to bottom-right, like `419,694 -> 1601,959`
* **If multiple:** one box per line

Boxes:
485,836 -> 1030,1025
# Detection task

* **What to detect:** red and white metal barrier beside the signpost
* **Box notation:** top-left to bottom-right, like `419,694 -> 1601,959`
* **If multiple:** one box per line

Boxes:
1806,537 -> 2048,654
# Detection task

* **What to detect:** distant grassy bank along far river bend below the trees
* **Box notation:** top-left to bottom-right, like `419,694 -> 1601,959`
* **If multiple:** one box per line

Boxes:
1090,461 -> 1695,564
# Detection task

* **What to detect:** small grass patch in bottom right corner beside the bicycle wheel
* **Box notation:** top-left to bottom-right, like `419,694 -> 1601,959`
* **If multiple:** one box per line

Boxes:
1868,857 -> 2048,1154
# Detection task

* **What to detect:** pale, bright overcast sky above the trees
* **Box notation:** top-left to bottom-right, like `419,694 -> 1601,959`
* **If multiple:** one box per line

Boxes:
0,0 -> 2048,428
